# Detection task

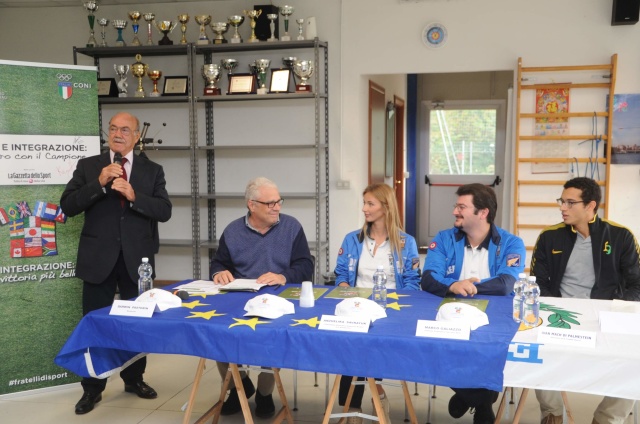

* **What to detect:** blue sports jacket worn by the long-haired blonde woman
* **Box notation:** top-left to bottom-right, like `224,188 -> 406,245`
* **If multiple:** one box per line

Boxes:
335,230 -> 420,290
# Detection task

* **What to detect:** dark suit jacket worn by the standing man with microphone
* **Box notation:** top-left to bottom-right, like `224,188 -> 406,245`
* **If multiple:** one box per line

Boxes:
60,152 -> 171,284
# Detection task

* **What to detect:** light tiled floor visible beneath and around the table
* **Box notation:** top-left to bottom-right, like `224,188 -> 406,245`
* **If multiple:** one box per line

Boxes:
0,355 -> 634,424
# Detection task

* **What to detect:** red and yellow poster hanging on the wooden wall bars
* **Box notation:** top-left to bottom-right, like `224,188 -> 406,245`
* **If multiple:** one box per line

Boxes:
531,88 -> 569,174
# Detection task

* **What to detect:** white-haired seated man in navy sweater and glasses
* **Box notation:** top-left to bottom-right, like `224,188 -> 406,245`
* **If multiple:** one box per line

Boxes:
210,177 -> 313,418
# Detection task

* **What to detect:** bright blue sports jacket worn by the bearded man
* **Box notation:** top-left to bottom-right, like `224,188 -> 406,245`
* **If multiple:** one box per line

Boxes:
420,224 -> 526,297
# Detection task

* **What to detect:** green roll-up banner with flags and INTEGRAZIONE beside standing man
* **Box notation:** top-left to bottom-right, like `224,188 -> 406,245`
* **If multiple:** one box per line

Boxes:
0,61 -> 100,395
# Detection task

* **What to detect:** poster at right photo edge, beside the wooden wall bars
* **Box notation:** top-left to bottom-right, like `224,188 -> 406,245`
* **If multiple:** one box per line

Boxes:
611,94 -> 640,165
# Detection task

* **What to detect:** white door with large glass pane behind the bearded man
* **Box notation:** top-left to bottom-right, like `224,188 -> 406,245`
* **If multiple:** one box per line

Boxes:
418,100 -> 506,246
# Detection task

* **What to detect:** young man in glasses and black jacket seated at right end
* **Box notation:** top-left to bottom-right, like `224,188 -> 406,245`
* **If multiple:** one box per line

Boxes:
531,177 -> 640,424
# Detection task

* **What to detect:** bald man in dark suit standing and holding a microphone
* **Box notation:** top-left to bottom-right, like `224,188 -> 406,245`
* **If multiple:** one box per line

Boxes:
60,112 -> 171,414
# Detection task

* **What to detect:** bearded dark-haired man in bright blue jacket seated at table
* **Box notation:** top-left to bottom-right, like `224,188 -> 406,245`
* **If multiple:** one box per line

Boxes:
420,184 -> 526,424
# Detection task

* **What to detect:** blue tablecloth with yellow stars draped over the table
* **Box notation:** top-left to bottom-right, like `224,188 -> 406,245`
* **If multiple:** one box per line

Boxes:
55,283 -> 517,391
